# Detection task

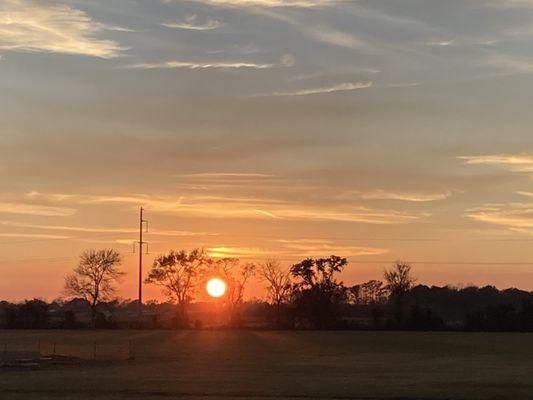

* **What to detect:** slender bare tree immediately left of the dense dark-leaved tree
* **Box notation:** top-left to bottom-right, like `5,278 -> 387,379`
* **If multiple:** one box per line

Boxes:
258,259 -> 291,325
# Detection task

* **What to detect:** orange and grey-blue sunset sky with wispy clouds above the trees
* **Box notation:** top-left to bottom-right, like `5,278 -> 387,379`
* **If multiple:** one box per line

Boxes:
0,0 -> 533,300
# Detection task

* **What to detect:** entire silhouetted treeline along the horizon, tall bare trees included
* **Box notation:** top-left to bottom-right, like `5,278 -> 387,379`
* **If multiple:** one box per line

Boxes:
0,249 -> 533,331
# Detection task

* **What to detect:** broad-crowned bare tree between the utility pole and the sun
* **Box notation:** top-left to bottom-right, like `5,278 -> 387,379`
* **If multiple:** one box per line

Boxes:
145,249 -> 211,323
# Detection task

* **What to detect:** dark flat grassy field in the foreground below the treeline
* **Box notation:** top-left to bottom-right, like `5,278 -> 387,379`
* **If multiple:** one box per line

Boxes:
0,331 -> 533,400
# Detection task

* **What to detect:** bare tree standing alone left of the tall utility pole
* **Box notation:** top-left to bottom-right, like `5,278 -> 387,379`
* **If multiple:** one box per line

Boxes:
64,249 -> 124,326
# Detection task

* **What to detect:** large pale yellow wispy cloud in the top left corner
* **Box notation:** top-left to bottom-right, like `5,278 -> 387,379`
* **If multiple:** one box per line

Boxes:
0,0 -> 123,58
